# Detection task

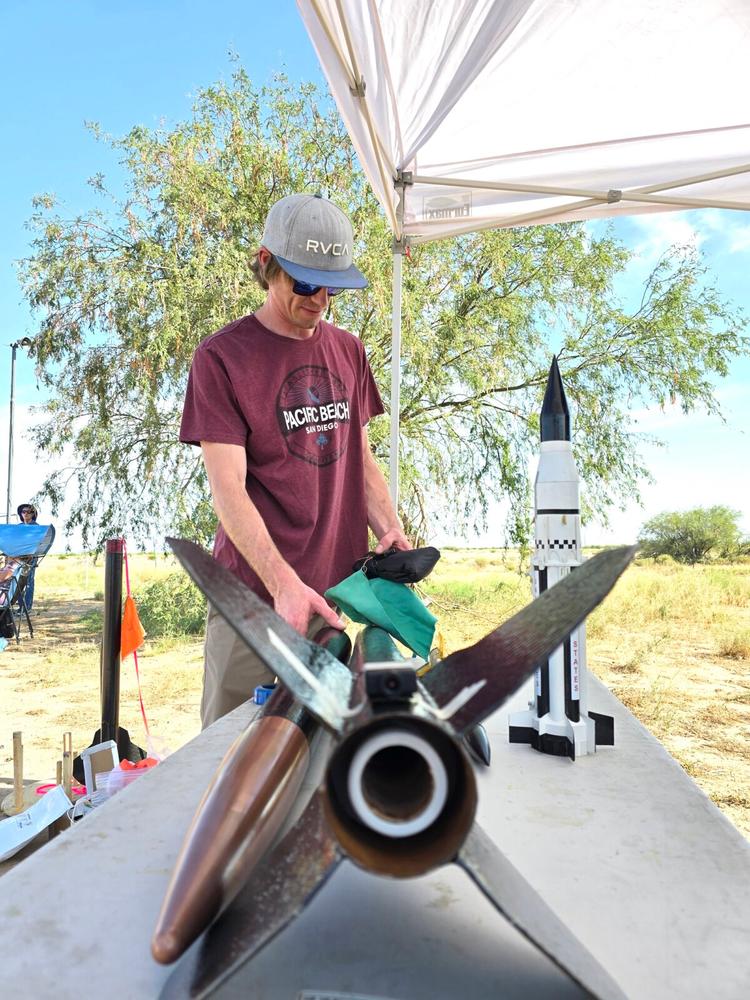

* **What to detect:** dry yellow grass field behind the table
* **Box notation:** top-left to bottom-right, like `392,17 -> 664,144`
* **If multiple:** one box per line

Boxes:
0,550 -> 750,837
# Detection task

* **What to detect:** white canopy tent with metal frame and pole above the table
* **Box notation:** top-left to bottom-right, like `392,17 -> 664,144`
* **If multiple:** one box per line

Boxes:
298,0 -> 750,498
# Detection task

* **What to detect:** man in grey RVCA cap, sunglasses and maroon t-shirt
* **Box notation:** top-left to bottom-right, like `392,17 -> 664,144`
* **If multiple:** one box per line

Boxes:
180,194 -> 410,728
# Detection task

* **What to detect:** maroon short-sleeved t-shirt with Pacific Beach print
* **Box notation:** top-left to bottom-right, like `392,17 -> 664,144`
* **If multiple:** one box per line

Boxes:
180,316 -> 383,603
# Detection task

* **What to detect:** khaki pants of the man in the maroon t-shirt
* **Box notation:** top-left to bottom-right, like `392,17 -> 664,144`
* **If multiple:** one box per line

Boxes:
201,605 -> 325,729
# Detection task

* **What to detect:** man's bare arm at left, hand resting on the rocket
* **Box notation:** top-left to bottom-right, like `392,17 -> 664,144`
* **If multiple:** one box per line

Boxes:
201,441 -> 344,635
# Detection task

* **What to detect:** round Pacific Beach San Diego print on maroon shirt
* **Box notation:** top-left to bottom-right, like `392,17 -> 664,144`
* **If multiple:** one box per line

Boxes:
276,365 -> 351,465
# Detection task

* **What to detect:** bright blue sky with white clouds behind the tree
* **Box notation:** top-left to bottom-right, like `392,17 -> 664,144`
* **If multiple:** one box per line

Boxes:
0,0 -> 750,544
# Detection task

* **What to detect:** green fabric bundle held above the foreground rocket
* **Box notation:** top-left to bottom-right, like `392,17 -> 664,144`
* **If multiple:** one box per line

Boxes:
325,570 -> 437,660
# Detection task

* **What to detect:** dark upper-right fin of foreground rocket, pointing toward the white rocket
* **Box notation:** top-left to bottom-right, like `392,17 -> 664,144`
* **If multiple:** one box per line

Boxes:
422,545 -> 637,735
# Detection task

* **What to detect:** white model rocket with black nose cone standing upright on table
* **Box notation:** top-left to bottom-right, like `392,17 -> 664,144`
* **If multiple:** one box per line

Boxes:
508,357 -> 615,760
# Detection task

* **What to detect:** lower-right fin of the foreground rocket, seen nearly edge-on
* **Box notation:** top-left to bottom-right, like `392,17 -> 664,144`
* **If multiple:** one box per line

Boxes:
456,823 -> 625,1000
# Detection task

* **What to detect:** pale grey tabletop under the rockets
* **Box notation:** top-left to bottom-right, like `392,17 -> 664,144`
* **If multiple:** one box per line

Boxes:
2,677 -> 750,1000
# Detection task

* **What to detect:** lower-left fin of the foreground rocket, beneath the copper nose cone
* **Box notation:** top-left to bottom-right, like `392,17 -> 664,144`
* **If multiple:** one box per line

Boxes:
160,790 -> 342,1000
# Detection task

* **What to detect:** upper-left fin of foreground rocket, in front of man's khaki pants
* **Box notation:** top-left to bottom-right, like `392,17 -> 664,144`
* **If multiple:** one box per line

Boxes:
167,538 -> 352,732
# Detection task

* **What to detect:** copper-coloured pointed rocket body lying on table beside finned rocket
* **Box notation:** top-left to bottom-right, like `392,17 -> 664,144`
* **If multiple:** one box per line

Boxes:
151,629 -> 350,964
